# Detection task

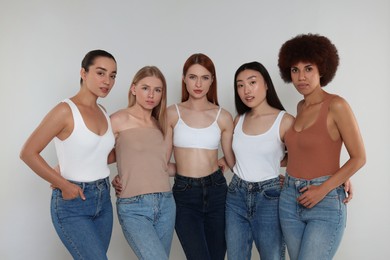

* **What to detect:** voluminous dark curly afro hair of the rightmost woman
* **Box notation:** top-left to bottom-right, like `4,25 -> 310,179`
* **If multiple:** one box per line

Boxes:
278,34 -> 339,87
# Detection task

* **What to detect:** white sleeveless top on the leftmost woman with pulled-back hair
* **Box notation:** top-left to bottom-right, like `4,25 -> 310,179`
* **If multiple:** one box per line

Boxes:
54,99 -> 115,182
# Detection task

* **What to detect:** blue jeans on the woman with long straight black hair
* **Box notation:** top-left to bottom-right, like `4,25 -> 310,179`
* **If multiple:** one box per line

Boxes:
226,175 -> 286,260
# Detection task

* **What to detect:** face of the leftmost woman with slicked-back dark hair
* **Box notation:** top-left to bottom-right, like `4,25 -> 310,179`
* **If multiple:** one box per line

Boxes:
80,57 -> 117,97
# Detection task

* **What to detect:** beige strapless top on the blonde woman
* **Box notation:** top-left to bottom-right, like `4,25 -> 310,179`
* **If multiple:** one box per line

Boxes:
115,128 -> 171,198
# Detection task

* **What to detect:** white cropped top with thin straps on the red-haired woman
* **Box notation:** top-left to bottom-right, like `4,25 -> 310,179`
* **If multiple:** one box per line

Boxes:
173,104 -> 221,150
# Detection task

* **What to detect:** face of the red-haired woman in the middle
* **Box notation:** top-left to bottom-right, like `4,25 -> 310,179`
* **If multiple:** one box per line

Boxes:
183,64 -> 213,98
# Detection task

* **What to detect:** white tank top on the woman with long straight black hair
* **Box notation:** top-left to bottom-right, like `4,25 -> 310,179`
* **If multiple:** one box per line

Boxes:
232,111 -> 285,182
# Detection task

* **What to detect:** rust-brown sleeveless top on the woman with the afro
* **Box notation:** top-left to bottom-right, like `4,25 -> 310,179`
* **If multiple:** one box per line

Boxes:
285,95 -> 342,179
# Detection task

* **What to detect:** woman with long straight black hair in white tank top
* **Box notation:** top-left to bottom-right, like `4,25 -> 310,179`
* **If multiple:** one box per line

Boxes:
226,62 -> 294,260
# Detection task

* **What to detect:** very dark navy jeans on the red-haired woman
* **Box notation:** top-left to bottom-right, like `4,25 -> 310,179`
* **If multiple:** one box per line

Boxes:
172,170 -> 227,260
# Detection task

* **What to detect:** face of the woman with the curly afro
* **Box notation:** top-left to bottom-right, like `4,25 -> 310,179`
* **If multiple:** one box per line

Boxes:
291,62 -> 321,96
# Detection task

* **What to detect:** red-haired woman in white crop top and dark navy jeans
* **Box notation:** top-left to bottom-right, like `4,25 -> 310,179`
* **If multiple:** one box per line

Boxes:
167,54 -> 234,260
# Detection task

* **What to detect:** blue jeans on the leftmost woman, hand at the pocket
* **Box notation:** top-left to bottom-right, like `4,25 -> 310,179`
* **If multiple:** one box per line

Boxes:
51,177 -> 113,260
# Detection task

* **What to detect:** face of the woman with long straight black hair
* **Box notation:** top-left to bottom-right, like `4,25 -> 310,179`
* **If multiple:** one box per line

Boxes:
236,69 -> 267,108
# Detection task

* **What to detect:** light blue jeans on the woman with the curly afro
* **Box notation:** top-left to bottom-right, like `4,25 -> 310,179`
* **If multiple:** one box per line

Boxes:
279,174 -> 347,260
